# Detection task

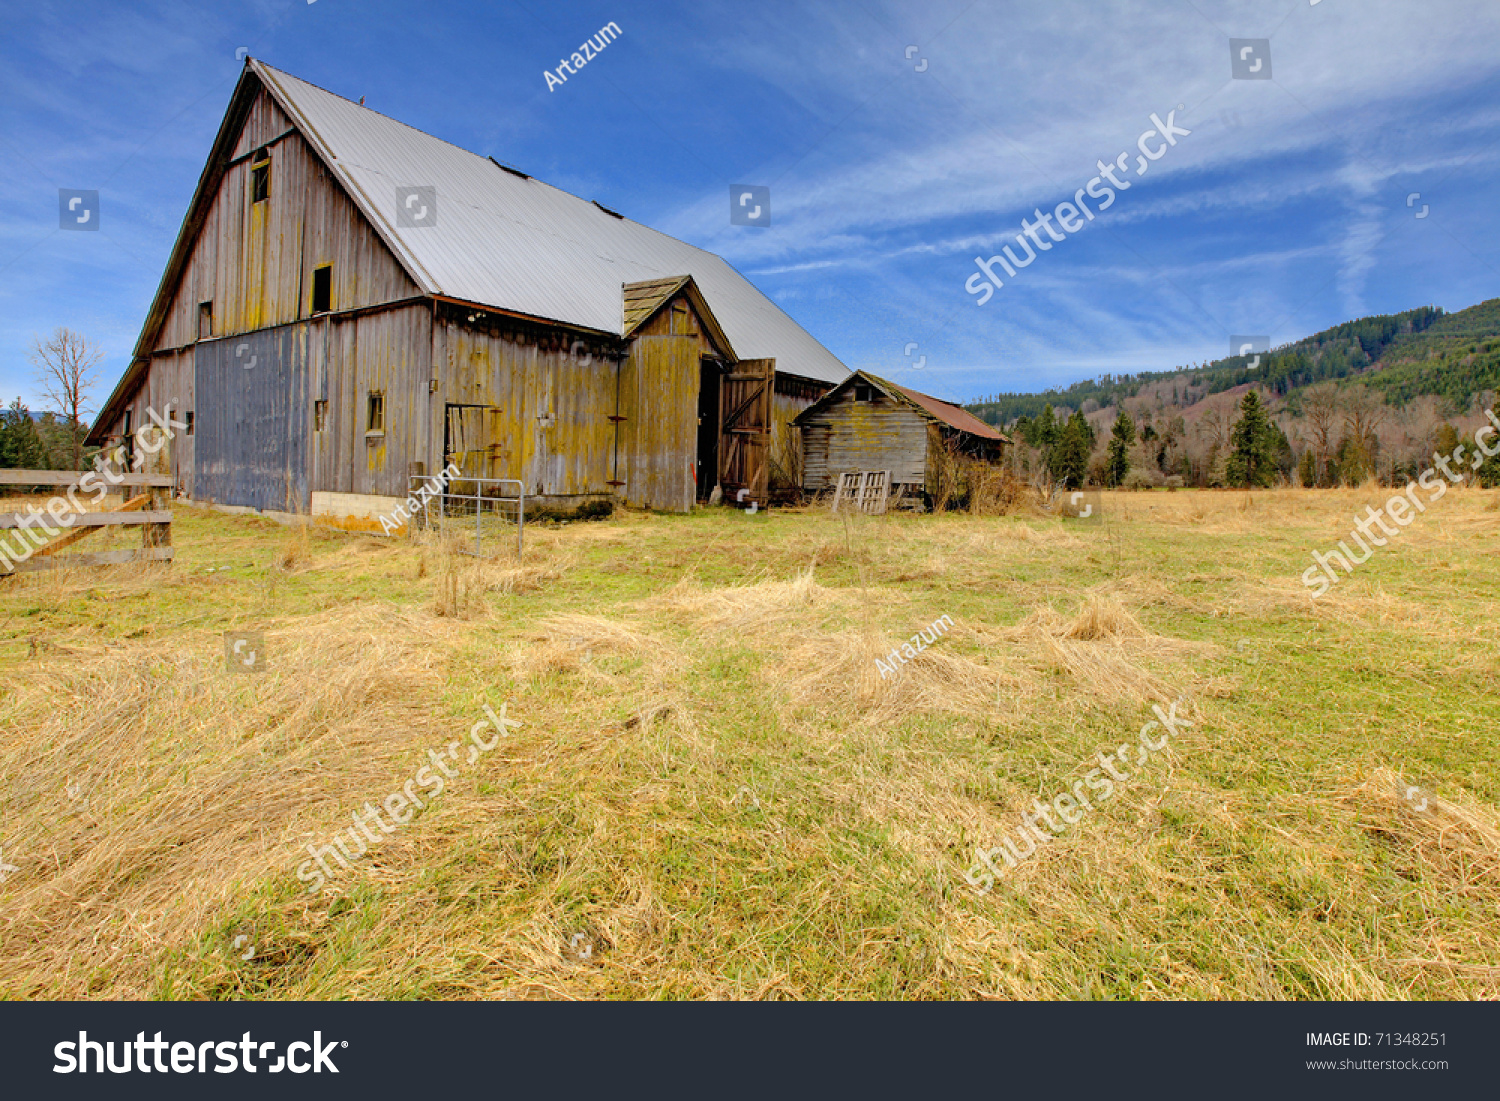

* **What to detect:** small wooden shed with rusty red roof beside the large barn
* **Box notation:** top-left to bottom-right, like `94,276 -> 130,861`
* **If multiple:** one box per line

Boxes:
792,371 -> 1011,494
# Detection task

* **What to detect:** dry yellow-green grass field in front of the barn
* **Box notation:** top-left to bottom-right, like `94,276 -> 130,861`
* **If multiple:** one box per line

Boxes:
0,486 -> 1500,999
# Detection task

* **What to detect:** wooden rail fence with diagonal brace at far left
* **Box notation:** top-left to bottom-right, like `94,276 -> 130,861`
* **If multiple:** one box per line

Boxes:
0,470 -> 174,578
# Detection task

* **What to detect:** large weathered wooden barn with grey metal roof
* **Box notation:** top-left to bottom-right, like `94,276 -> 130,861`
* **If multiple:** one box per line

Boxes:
90,59 -> 849,518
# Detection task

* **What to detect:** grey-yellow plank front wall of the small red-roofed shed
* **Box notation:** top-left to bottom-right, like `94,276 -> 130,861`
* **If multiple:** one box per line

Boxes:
803,387 -> 927,494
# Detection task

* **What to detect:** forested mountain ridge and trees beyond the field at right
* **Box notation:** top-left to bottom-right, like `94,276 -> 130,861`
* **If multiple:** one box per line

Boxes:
968,299 -> 1500,488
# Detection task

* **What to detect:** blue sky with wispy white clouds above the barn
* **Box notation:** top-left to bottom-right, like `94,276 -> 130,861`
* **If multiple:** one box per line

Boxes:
0,0 -> 1500,417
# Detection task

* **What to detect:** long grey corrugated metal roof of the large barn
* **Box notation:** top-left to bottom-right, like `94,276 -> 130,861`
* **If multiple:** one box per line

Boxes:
248,59 -> 849,383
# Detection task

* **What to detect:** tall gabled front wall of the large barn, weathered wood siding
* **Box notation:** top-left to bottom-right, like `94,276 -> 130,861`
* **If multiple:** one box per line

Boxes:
97,90 -> 429,509
